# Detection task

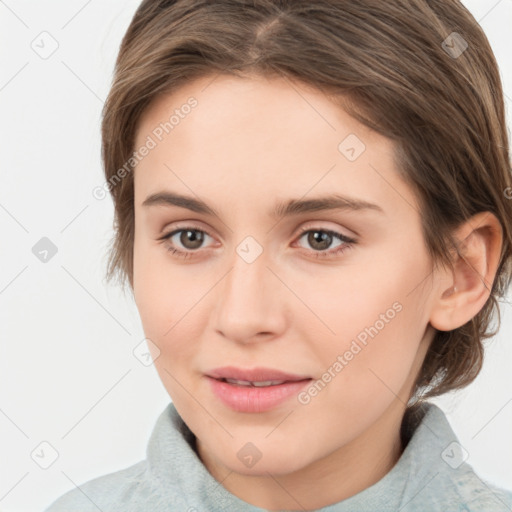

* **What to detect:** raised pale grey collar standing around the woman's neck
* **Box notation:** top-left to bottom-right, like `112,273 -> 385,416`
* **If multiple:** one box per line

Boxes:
143,402 -> 464,512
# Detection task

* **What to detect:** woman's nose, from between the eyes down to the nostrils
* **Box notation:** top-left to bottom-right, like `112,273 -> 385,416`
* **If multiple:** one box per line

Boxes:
213,247 -> 289,344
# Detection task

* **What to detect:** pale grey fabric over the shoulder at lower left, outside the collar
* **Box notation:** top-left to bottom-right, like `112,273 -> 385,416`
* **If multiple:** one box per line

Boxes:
44,461 -> 151,512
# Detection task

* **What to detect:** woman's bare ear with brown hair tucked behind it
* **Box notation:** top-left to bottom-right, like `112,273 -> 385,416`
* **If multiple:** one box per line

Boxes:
430,212 -> 503,331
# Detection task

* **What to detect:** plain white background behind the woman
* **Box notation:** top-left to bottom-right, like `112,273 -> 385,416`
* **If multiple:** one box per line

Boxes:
0,0 -> 512,512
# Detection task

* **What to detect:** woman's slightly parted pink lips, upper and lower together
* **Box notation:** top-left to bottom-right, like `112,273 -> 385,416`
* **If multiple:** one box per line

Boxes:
205,367 -> 312,413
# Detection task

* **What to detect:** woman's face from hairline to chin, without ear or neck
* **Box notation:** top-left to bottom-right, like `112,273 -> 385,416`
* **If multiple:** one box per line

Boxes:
133,75 -> 440,475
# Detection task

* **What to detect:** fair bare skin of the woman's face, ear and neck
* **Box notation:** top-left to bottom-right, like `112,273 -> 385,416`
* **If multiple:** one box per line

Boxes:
133,75 -> 501,510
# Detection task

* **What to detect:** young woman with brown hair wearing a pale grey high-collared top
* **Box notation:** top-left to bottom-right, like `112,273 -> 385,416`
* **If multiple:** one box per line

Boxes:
48,0 -> 512,512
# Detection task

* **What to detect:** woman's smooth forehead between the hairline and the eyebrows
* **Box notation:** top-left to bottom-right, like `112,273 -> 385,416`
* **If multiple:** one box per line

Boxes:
135,75 -> 420,216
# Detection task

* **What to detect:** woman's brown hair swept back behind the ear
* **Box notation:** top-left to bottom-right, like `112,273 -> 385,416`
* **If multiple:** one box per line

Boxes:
98,0 -> 512,406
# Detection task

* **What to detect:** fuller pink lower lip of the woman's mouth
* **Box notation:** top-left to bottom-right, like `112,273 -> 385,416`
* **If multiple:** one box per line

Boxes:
206,376 -> 311,412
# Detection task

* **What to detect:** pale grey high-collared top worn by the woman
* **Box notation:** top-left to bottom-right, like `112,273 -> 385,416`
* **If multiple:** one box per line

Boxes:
45,402 -> 512,512
